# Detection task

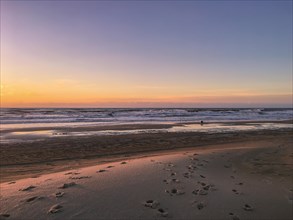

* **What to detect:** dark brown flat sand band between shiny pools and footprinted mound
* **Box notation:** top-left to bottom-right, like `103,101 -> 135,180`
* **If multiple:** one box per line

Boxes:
0,126 -> 292,182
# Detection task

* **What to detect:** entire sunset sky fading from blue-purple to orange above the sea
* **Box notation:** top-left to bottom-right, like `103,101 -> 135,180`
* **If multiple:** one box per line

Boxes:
1,1 -> 292,107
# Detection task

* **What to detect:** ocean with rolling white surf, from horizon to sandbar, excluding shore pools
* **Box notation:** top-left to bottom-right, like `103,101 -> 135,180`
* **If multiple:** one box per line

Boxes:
0,108 -> 293,128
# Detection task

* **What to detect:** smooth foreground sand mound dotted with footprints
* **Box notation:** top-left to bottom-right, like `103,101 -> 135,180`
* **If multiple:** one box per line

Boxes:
0,133 -> 293,220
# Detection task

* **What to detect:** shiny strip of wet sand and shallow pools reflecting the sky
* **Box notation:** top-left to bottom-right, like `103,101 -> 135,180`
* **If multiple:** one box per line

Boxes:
1,122 -> 293,143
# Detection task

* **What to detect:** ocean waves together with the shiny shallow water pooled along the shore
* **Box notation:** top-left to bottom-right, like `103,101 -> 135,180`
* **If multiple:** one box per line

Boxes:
0,108 -> 293,143
